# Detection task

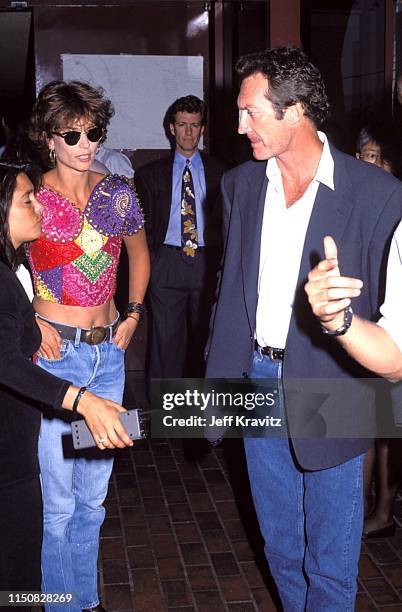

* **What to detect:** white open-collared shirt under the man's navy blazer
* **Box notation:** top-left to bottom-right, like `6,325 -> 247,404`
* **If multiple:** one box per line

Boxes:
255,132 -> 335,348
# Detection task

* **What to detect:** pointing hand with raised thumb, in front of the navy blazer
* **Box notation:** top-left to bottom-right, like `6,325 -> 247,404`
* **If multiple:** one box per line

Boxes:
304,236 -> 363,331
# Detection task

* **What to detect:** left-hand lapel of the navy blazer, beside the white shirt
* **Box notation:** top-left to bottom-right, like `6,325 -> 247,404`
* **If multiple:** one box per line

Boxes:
240,162 -> 268,332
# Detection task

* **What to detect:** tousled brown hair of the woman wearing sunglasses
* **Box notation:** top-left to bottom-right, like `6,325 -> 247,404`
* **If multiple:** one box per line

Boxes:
28,81 -> 114,167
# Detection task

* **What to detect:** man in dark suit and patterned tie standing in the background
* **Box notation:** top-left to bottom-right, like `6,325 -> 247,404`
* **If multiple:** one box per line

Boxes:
135,95 -> 225,378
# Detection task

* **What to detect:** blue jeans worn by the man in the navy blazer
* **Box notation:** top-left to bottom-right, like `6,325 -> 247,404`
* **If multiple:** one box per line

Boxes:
244,352 -> 363,612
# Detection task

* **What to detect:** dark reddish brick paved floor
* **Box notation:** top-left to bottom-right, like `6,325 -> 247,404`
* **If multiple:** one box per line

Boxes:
100,376 -> 402,612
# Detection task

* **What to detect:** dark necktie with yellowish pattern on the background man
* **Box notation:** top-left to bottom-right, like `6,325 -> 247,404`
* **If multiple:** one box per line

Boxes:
180,159 -> 198,263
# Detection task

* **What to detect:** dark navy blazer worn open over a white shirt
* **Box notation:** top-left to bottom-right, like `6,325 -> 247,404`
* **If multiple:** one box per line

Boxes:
206,147 -> 402,470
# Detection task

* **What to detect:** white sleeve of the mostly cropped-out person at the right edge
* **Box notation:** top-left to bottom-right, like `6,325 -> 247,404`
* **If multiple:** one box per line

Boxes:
378,221 -> 402,351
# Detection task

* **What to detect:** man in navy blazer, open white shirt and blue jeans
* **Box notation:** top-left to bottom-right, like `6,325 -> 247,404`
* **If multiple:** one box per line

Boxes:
206,48 -> 402,612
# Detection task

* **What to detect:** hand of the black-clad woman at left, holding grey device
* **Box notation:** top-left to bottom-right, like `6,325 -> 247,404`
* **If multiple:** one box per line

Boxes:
71,387 -> 133,450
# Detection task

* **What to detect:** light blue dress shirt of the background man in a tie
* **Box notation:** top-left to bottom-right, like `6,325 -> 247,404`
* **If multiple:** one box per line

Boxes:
165,151 -> 206,246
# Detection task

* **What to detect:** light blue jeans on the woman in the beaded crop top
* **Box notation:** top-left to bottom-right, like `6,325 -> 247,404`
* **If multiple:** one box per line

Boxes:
38,340 -> 124,612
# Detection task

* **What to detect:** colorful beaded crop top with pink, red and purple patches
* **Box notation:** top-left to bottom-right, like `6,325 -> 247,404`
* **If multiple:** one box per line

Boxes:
27,174 -> 144,306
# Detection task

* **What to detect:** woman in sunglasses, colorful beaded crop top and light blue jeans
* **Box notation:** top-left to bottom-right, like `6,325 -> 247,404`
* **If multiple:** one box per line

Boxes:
28,81 -> 149,611
